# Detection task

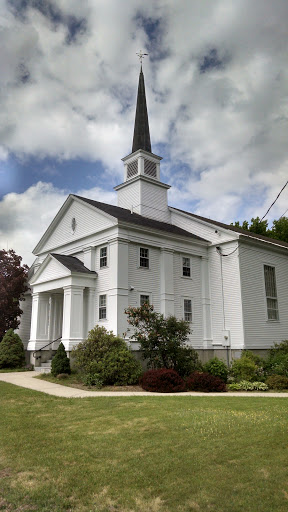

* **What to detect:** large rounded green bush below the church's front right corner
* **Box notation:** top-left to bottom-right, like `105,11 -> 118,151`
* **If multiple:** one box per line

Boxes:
72,326 -> 142,387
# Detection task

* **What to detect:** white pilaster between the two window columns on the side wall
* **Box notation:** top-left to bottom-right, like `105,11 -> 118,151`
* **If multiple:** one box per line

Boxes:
160,249 -> 174,317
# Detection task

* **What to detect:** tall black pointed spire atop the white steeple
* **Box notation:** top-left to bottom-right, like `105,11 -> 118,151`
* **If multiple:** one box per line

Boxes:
132,66 -> 152,153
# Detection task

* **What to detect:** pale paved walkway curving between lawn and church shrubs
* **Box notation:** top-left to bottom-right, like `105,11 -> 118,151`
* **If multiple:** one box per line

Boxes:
0,371 -> 288,398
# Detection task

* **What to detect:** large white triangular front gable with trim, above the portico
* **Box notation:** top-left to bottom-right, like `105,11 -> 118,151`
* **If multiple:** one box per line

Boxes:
33,195 -> 117,255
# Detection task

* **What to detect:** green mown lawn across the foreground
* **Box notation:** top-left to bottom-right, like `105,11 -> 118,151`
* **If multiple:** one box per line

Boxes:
0,383 -> 288,512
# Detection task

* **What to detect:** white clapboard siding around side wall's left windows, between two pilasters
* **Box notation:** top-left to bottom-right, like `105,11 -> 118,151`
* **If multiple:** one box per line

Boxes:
128,243 -> 160,312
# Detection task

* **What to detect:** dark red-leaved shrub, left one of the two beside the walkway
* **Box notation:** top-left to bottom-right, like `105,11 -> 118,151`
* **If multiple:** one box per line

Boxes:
140,368 -> 186,393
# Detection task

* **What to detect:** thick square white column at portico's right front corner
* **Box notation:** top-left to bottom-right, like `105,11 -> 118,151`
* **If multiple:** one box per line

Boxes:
62,285 -> 84,351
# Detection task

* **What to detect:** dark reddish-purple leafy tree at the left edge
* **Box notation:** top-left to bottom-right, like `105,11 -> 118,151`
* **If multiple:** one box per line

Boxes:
0,249 -> 28,340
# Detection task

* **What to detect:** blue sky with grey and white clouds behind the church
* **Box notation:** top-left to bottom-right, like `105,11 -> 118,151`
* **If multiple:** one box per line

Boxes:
0,0 -> 288,264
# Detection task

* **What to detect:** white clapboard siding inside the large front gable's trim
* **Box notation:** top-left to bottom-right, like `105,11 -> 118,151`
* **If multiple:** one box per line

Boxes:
41,201 -> 113,252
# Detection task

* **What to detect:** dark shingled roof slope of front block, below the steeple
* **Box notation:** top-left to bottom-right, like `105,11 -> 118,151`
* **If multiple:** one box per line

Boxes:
73,194 -> 208,242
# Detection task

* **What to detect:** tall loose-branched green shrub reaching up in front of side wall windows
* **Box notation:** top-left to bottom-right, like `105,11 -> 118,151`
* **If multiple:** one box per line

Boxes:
125,304 -> 200,376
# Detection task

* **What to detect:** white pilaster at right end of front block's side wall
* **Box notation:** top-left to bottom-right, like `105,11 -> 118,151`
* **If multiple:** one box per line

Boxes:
201,257 -> 213,348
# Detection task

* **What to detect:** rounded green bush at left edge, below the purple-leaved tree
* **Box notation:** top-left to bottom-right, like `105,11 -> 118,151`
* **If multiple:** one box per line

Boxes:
0,329 -> 25,368
